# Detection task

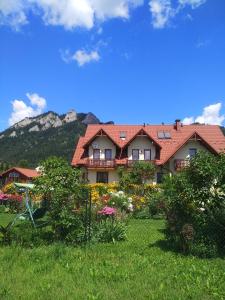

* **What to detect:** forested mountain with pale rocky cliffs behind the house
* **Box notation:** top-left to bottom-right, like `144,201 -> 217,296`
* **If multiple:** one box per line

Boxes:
0,110 -> 113,169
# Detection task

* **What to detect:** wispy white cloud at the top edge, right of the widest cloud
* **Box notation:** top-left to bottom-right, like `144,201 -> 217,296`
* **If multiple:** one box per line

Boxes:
149,0 -> 207,28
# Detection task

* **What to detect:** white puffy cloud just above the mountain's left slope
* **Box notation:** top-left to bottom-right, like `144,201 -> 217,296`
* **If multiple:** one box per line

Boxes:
9,93 -> 47,126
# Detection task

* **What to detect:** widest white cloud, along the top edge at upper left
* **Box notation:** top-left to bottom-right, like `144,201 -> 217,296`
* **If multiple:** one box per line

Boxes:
0,0 -> 144,29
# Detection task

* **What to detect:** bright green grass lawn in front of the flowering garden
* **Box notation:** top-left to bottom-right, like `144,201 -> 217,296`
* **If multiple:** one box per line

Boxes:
0,215 -> 225,300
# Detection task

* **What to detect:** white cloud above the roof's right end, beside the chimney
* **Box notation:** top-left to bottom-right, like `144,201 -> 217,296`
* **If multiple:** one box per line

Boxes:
183,102 -> 225,125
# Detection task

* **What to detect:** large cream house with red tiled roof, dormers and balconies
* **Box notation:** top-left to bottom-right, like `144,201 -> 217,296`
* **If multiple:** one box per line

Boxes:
72,120 -> 225,183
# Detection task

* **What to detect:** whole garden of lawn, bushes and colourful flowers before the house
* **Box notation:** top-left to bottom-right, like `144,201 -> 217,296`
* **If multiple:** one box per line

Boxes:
0,152 -> 225,299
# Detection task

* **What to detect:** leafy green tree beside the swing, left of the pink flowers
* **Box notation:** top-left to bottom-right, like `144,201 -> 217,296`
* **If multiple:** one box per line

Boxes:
35,157 -> 85,243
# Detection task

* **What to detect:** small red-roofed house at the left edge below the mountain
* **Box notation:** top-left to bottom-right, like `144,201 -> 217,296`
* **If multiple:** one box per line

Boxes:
0,167 -> 40,185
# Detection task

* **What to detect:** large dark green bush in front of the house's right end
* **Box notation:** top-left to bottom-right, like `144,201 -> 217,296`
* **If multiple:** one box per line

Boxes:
164,152 -> 225,256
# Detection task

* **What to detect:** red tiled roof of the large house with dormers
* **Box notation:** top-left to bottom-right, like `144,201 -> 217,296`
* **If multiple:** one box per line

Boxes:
72,124 -> 225,166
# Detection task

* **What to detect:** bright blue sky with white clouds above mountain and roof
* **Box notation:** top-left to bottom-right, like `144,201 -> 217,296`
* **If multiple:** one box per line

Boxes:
0,0 -> 225,131
